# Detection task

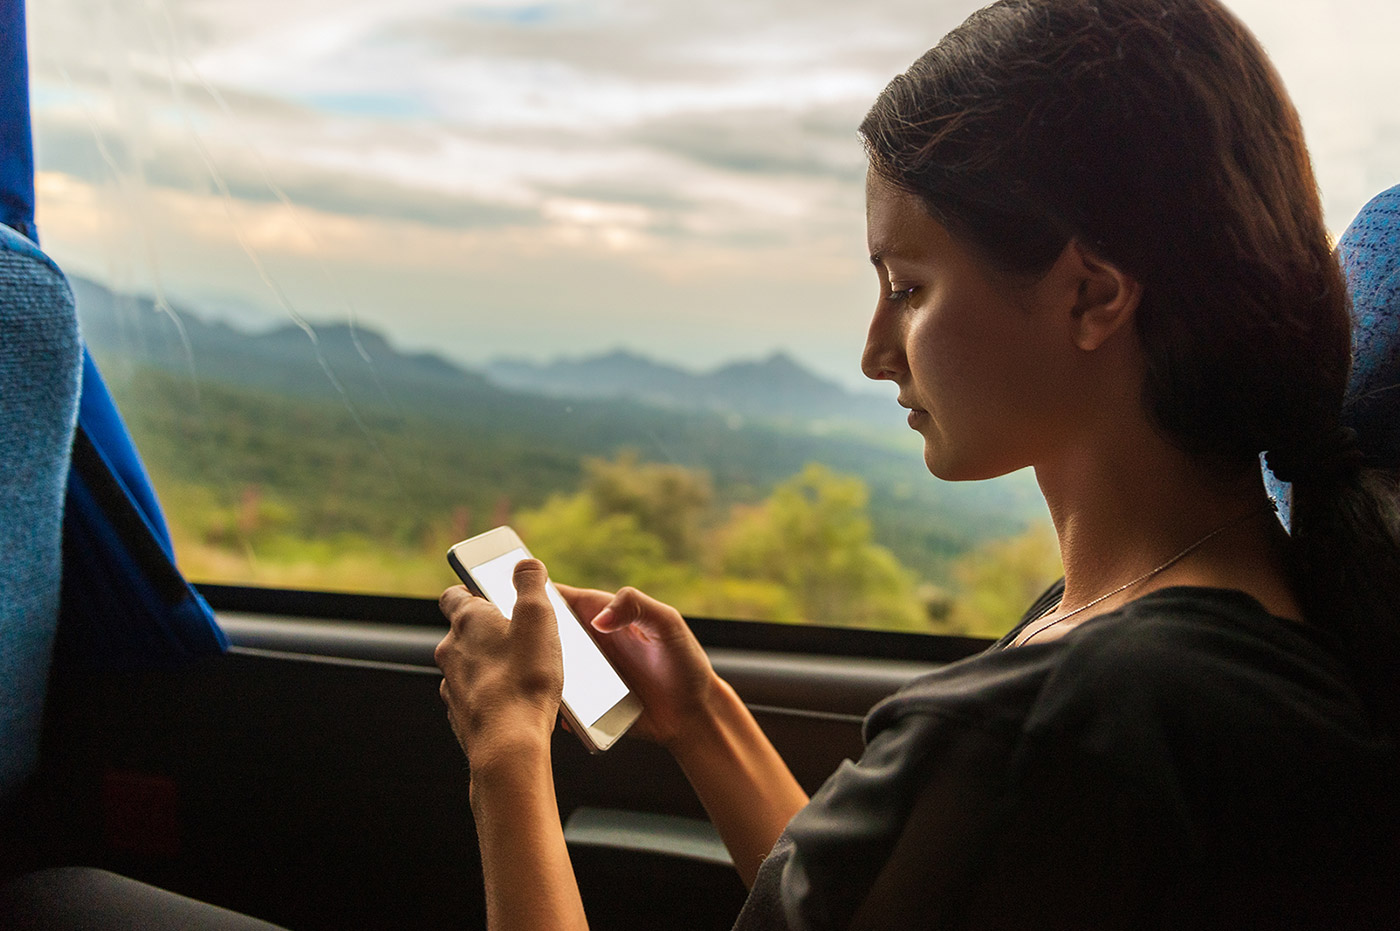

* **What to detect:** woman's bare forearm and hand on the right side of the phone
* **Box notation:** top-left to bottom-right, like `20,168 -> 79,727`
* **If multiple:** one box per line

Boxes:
559,585 -> 806,886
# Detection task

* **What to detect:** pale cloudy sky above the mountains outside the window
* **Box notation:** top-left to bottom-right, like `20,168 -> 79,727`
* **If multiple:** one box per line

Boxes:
28,0 -> 1400,386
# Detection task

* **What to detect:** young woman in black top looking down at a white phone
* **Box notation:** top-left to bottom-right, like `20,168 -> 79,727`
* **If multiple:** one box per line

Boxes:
438,0 -> 1400,930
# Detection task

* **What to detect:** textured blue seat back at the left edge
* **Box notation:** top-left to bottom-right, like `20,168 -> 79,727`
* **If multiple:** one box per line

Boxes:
0,225 -> 81,801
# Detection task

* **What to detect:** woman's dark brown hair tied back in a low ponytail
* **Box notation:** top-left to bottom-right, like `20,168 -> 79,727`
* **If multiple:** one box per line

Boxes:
861,0 -> 1400,728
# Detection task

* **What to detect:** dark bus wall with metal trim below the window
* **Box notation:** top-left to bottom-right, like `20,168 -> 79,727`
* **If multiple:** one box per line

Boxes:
22,589 -> 981,931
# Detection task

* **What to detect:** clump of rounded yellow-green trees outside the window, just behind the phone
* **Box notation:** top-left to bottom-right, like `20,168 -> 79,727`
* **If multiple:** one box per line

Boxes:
515,454 -> 928,630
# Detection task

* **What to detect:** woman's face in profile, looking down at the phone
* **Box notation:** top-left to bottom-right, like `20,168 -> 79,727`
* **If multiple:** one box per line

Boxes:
861,174 -> 1082,480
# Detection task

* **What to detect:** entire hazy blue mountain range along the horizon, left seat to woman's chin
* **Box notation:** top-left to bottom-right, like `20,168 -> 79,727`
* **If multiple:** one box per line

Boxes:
73,277 -> 902,433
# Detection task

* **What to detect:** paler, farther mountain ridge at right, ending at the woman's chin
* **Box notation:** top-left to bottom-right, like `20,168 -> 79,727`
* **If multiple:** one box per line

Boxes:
484,349 -> 899,426
